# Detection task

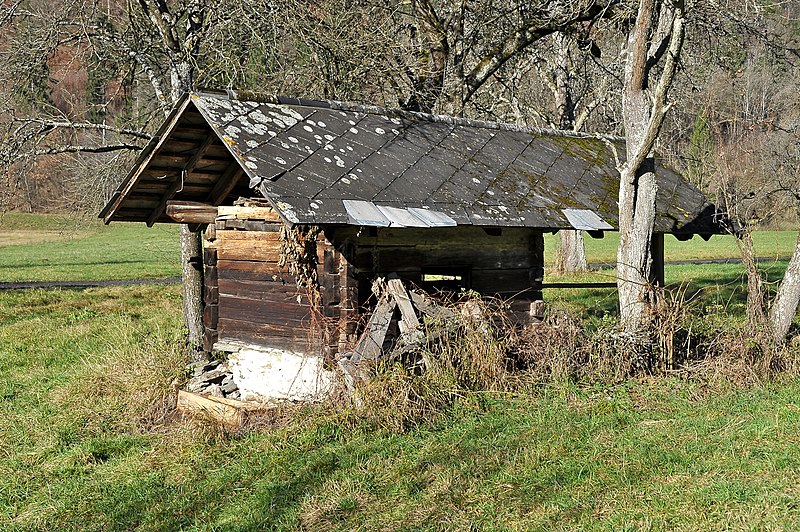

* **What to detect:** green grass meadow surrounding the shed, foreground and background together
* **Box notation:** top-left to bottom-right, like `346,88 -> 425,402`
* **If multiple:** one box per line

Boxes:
0,215 -> 800,531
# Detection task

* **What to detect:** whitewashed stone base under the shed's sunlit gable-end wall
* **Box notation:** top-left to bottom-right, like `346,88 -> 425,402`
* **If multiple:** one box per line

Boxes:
214,342 -> 336,403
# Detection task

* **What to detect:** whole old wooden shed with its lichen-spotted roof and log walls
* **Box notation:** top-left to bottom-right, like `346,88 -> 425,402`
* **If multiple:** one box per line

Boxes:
100,92 -> 720,400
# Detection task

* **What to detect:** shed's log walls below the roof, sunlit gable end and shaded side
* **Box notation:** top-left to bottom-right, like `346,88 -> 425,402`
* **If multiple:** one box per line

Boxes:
204,206 -> 544,356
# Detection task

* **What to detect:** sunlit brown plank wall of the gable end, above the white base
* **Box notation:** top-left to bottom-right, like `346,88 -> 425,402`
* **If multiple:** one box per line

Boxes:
205,214 -> 321,354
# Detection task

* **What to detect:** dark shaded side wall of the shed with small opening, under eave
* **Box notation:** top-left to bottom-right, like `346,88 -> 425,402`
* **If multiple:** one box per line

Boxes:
332,226 -> 544,302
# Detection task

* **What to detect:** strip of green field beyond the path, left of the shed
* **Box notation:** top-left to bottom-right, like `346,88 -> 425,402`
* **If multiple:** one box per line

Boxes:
0,213 -> 180,282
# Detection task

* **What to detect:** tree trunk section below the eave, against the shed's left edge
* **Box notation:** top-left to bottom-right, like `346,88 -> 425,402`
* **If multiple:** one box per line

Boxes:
181,224 -> 206,362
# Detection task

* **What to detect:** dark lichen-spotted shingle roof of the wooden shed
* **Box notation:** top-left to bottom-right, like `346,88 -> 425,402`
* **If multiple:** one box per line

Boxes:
104,93 -> 719,233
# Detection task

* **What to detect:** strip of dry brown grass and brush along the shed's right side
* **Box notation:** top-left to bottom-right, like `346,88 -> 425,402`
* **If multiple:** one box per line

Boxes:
334,290 -> 800,431
